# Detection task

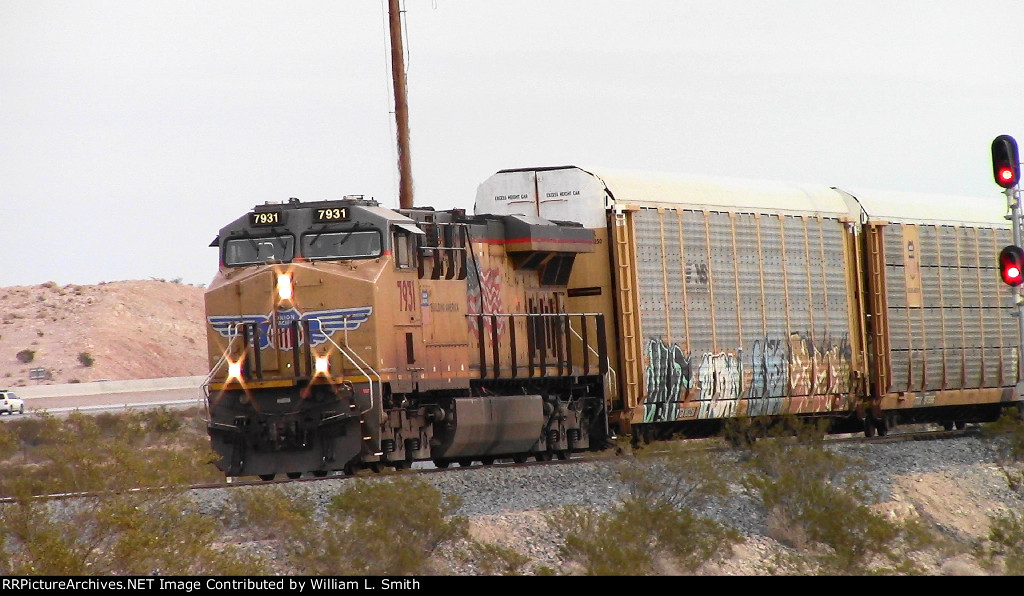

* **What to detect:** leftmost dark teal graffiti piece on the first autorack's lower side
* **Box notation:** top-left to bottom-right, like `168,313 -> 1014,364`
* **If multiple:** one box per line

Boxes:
644,339 -> 693,422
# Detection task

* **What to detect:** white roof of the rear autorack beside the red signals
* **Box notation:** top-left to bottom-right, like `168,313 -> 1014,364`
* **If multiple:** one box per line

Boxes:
839,188 -> 1010,227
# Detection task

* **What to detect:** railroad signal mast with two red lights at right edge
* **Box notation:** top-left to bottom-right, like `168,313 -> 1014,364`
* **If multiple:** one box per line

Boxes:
992,134 -> 1024,387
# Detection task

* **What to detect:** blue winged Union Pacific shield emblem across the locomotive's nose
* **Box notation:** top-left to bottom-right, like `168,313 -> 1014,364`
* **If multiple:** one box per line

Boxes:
207,306 -> 374,350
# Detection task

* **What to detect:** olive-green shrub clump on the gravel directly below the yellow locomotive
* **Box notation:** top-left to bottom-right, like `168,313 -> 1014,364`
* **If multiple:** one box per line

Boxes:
238,475 -> 468,576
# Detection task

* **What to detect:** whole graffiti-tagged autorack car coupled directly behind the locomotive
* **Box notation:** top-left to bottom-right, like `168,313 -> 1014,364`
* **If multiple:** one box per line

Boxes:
477,166 -> 866,430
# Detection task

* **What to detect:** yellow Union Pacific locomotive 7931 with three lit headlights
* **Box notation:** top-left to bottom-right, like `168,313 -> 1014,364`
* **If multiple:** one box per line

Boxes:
206,199 -> 606,478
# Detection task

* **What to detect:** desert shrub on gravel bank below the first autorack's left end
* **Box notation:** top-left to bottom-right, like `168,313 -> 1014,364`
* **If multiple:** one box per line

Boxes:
546,441 -> 742,576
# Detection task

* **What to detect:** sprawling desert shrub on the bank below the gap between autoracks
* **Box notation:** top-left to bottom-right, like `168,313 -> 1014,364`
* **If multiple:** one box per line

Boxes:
742,439 -> 933,574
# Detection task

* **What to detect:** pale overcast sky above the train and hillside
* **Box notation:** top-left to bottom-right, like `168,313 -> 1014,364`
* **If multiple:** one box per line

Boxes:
0,0 -> 1024,286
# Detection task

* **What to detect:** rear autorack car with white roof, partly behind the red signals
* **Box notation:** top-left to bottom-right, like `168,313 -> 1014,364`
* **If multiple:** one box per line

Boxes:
854,191 -> 1018,409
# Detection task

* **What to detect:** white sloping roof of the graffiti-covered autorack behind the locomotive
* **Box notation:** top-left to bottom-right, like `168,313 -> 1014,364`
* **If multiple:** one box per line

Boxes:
581,168 -> 859,217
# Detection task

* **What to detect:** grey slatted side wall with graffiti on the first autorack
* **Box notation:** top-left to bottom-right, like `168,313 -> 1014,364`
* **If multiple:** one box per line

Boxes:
628,209 -> 863,430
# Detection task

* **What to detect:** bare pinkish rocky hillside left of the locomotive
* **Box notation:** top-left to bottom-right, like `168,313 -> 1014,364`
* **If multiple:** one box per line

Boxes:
0,280 -> 207,387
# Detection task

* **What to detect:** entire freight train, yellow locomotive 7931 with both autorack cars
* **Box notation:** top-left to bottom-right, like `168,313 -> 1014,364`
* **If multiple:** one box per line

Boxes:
206,166 -> 1022,479
